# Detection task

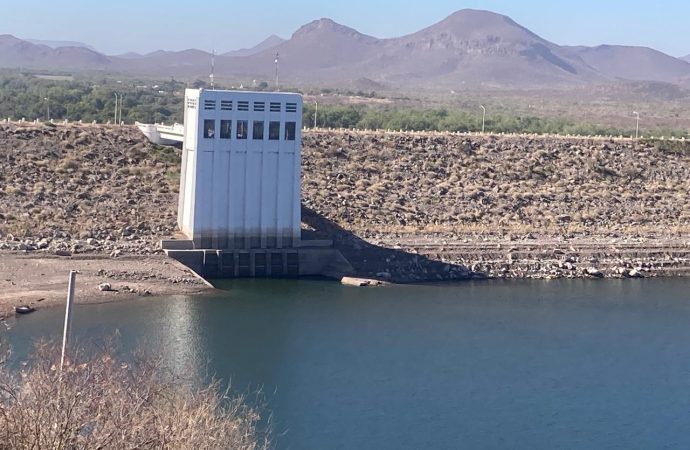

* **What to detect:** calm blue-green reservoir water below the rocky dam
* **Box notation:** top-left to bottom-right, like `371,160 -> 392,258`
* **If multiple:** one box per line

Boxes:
7,279 -> 690,450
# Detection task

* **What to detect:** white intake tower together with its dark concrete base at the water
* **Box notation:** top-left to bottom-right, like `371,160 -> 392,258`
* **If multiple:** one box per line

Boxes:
162,89 -> 351,278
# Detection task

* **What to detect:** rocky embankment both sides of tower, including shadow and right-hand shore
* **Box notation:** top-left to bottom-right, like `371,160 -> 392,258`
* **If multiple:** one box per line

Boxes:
0,124 -> 690,312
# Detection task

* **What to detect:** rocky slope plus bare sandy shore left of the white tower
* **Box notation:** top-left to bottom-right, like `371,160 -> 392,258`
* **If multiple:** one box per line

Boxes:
0,125 -> 207,317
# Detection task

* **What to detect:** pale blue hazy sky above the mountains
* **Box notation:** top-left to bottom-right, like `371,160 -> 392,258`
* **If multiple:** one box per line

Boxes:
0,0 -> 690,56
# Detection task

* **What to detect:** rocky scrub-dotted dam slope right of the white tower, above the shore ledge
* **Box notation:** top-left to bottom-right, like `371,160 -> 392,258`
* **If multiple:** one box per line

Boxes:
303,132 -> 690,236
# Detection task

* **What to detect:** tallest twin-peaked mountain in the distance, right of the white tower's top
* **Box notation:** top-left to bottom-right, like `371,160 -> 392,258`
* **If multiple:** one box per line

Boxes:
212,10 -> 605,89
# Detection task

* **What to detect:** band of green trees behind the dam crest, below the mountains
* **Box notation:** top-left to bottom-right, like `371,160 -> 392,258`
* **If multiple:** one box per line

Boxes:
0,73 -> 687,137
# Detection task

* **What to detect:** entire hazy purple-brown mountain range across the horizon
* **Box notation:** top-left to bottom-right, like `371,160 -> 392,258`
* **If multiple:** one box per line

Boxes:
0,9 -> 690,90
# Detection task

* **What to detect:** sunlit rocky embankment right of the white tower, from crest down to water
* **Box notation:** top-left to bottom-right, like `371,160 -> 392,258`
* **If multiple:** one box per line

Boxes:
302,132 -> 690,280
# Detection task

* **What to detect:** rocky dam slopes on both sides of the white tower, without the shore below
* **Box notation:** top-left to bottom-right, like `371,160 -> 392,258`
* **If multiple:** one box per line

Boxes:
0,125 -> 690,245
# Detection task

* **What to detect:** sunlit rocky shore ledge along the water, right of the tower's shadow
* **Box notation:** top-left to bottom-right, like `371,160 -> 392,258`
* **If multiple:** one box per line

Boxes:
358,234 -> 690,279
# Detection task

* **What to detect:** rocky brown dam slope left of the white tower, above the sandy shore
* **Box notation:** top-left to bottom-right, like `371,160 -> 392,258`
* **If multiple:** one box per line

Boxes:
0,125 -> 179,256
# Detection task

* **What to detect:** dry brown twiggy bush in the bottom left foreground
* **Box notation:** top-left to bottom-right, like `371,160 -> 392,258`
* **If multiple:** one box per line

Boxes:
0,343 -> 269,450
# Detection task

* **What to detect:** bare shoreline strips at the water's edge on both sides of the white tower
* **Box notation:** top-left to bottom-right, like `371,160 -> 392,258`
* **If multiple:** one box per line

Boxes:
0,234 -> 690,318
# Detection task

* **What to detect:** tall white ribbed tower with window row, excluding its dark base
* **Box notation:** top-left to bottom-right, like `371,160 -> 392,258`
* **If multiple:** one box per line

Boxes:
178,89 -> 302,249
